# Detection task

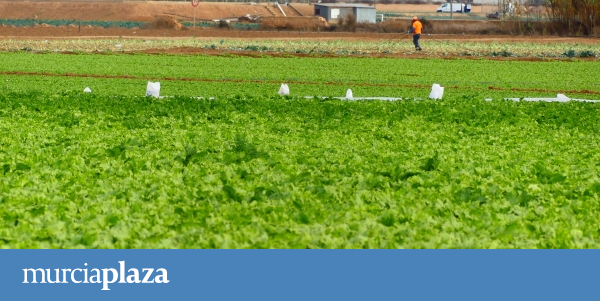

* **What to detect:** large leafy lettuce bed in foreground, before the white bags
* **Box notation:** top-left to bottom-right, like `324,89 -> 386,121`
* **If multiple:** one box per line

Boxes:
0,93 -> 600,248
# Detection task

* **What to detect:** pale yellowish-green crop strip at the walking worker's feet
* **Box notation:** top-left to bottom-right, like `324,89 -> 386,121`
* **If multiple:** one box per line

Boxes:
0,36 -> 600,58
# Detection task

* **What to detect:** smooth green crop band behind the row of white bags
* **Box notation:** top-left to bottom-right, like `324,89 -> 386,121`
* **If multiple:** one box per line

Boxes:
0,52 -> 600,99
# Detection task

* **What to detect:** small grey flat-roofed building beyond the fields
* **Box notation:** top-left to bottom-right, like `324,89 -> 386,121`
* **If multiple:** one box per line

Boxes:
314,3 -> 376,23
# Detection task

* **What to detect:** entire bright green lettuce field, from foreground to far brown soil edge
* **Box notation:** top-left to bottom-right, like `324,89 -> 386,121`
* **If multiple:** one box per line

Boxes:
0,52 -> 600,248
